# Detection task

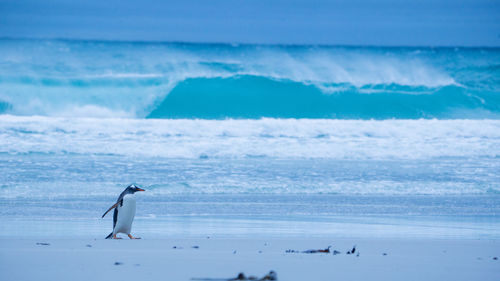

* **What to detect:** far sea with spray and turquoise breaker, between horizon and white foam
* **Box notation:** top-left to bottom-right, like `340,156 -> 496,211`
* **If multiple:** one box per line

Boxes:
0,39 -> 500,119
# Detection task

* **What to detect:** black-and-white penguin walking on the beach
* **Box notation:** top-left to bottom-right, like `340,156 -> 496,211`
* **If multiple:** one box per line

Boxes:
102,184 -> 145,239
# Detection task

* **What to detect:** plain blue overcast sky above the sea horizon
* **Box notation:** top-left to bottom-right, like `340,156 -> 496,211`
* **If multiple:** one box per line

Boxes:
0,0 -> 500,47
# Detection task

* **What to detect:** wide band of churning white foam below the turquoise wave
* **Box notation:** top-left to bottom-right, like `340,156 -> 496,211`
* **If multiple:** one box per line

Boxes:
0,115 -> 500,159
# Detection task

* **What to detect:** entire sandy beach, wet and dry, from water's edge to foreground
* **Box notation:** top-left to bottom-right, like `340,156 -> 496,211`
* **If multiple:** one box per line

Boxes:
0,192 -> 500,281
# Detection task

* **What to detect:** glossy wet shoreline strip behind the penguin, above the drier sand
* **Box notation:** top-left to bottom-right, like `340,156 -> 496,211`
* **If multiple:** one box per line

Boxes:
0,194 -> 500,240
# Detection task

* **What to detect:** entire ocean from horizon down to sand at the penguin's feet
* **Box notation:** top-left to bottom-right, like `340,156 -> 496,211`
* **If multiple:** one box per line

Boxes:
0,39 -> 500,239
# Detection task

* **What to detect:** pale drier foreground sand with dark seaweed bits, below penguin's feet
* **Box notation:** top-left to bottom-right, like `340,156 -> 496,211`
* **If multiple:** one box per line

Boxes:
0,237 -> 500,281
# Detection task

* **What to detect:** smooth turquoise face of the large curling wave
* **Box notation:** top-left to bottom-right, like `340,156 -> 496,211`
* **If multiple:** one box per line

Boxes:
147,75 -> 500,119
